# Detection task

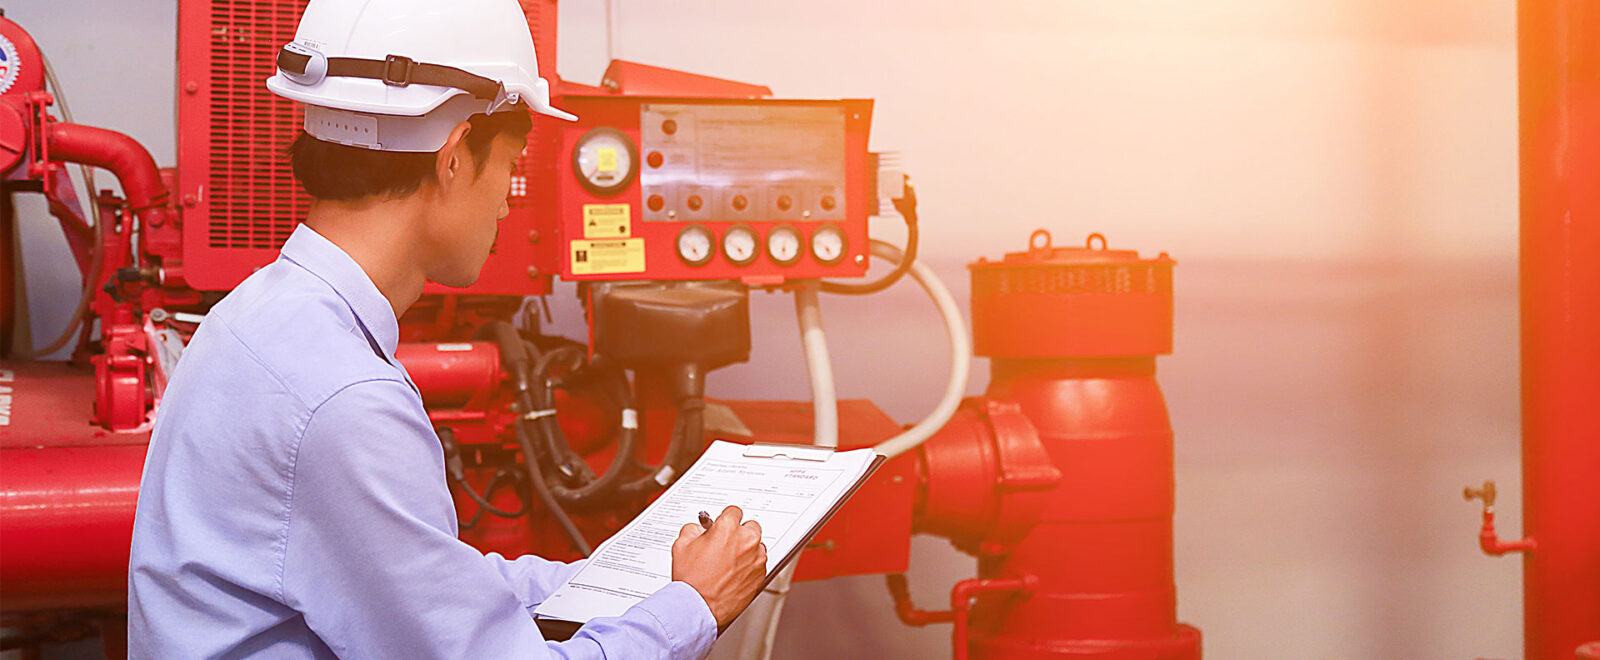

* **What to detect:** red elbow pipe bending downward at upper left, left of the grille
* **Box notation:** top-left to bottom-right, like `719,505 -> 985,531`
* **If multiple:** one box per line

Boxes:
46,123 -> 170,226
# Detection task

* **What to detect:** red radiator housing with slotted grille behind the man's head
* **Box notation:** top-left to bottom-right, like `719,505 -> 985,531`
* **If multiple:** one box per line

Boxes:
174,0 -> 557,295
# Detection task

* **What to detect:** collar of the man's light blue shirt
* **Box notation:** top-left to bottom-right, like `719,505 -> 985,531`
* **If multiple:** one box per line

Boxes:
282,223 -> 400,357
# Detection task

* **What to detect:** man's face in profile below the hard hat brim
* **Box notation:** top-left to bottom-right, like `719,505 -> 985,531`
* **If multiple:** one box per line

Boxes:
427,133 -> 526,287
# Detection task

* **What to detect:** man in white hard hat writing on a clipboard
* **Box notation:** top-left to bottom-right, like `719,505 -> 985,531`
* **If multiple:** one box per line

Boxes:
128,0 -> 766,658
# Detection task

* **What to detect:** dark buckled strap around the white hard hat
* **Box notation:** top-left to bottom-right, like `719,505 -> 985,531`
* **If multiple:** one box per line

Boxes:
278,43 -> 507,106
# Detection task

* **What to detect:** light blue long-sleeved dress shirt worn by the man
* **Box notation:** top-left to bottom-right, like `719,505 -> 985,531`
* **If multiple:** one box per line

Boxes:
128,226 -> 717,660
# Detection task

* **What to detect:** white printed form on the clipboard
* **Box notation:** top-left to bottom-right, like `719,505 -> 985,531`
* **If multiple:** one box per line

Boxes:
534,441 -> 880,623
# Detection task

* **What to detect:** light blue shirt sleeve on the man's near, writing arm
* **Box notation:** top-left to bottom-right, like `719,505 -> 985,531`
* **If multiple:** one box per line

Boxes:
278,380 -> 717,660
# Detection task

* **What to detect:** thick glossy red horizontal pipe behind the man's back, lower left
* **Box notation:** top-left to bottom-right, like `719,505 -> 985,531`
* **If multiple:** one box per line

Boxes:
0,444 -> 146,614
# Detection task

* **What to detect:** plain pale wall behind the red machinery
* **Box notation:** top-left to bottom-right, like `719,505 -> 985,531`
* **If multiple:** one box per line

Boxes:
6,0 -> 1522,660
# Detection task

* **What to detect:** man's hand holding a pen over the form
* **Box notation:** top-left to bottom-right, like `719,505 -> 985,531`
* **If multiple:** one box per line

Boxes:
672,506 -> 766,628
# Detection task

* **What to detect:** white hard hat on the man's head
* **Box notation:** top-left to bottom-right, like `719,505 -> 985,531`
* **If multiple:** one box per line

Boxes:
267,0 -> 578,152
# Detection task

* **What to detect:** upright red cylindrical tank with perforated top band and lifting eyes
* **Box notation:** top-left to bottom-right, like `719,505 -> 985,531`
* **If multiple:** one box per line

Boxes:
970,231 -> 1200,660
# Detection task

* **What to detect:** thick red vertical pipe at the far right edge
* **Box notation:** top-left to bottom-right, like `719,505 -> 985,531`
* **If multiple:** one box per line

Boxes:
1517,0 -> 1600,660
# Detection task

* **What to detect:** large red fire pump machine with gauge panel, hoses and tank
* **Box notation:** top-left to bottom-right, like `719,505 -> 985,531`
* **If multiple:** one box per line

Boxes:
0,0 -> 1200,658
